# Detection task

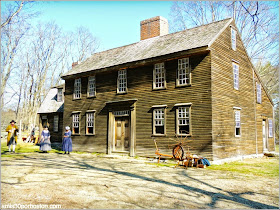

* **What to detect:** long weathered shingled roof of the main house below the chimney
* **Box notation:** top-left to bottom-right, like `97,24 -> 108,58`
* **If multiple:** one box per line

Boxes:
62,18 -> 232,78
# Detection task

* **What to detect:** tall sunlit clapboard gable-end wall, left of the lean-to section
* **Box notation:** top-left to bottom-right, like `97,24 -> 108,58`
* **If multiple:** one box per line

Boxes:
210,22 -> 272,159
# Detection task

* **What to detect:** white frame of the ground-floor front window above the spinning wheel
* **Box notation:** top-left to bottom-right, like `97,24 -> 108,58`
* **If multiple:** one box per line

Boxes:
176,106 -> 192,136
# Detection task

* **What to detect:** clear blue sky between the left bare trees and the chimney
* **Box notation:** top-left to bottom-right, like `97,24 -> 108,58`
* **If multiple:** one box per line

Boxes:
31,1 -> 172,51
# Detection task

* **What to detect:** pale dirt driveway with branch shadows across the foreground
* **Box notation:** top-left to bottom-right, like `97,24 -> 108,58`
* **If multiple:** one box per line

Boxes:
1,153 -> 279,209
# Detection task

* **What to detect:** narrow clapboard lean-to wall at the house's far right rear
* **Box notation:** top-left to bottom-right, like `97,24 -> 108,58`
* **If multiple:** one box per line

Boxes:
254,73 -> 275,153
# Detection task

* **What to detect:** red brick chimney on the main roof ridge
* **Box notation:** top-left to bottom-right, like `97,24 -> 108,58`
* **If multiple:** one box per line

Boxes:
140,16 -> 168,40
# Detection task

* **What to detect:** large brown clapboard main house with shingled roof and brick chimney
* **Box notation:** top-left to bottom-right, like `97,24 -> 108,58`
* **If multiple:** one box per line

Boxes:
62,16 -> 275,160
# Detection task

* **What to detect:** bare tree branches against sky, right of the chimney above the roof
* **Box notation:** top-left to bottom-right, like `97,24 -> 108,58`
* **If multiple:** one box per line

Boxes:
170,1 -> 279,63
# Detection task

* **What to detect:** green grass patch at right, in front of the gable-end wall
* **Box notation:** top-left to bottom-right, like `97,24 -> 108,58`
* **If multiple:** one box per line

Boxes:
207,157 -> 279,177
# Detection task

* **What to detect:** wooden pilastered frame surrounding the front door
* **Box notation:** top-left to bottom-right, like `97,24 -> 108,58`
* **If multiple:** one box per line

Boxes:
106,100 -> 137,157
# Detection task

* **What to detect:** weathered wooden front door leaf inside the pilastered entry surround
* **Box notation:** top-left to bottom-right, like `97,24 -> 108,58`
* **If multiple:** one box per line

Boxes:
114,117 -> 130,151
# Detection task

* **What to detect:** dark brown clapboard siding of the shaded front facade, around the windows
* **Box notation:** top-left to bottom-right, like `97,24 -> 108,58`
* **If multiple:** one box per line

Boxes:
64,53 -> 212,159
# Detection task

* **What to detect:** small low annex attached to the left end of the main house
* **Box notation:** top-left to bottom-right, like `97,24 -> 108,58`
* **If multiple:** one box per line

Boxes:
38,84 -> 64,143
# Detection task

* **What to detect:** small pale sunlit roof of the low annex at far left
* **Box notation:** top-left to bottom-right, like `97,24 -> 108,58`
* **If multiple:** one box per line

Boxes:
38,88 -> 64,114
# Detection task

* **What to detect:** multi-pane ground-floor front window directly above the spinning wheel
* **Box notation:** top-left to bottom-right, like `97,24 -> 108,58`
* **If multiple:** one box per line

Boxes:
177,107 -> 190,135
